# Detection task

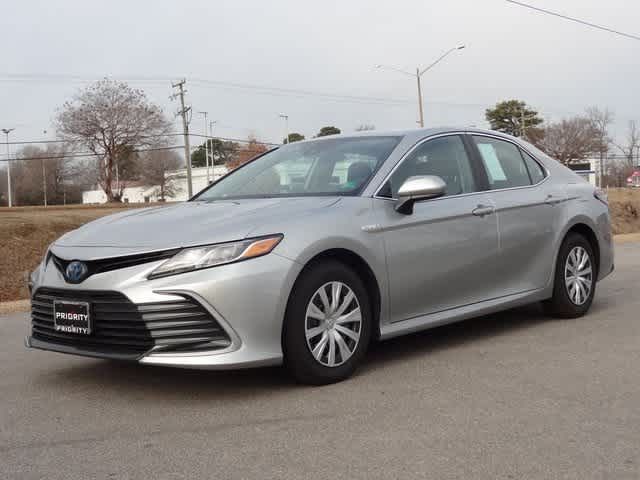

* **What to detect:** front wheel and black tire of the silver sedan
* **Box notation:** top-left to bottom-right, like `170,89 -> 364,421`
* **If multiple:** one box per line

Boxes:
282,260 -> 372,385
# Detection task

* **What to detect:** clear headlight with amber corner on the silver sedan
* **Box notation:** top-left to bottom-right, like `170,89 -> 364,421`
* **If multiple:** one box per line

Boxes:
148,234 -> 282,279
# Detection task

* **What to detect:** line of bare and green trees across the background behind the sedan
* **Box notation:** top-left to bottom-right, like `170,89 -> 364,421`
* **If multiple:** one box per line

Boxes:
0,79 -> 640,205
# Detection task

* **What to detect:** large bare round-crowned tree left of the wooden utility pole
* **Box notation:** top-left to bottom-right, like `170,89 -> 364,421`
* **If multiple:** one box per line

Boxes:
56,79 -> 171,201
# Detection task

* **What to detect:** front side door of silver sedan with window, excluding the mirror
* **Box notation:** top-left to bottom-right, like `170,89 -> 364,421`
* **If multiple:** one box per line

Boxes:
375,135 -> 498,322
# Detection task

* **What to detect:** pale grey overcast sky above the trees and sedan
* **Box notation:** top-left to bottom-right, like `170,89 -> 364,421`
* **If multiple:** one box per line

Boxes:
0,0 -> 640,153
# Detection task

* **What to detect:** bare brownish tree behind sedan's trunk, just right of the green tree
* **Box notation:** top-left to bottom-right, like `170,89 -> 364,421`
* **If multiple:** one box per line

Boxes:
538,117 -> 601,165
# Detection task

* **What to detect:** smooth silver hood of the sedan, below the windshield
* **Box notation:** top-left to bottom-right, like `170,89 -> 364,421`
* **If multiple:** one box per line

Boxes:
52,197 -> 340,259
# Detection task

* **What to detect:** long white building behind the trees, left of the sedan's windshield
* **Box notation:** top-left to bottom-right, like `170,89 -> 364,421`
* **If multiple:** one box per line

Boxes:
82,165 -> 228,203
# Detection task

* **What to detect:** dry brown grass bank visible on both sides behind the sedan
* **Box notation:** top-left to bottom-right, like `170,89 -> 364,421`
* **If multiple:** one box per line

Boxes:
0,189 -> 640,302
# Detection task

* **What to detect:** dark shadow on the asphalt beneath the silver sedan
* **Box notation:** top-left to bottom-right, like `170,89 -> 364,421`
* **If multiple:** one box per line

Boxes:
39,299 -> 607,400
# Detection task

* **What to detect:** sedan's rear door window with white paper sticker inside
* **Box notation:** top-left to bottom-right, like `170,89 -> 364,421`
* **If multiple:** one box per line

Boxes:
473,135 -> 537,190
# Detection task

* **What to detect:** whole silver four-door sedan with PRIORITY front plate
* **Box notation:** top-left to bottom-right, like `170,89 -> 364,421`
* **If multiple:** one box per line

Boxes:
26,129 -> 613,384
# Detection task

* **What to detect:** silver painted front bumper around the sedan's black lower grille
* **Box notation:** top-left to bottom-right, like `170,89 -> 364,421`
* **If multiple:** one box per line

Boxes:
25,252 -> 302,369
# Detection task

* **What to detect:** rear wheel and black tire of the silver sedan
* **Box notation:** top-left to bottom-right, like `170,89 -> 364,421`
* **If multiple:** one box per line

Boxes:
542,233 -> 598,318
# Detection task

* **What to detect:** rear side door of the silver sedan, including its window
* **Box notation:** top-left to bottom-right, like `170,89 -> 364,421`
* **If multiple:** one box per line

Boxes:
471,135 -> 566,295
